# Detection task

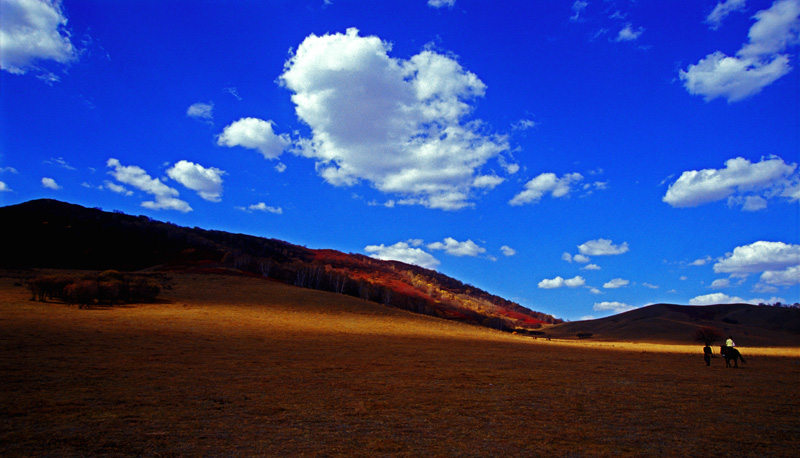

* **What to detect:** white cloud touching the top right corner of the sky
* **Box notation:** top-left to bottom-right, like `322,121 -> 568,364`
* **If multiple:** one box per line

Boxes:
680,0 -> 800,103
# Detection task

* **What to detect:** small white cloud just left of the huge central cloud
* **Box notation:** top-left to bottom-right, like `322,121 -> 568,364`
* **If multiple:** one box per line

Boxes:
217,118 -> 291,159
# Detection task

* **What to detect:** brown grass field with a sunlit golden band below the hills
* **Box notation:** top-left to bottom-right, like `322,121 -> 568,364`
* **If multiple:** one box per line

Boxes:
0,273 -> 800,458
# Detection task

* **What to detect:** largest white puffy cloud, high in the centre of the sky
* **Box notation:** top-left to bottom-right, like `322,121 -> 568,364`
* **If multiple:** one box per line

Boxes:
280,28 -> 509,210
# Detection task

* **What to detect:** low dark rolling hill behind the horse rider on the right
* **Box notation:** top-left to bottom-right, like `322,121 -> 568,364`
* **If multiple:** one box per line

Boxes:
547,304 -> 800,347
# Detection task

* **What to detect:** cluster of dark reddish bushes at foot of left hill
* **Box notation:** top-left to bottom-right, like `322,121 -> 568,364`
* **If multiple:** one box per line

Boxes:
28,270 -> 161,308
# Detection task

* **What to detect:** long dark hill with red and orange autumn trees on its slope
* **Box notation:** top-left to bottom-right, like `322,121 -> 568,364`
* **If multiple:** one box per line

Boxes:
0,199 -> 561,329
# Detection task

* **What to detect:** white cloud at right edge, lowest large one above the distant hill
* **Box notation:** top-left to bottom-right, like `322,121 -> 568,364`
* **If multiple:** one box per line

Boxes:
714,241 -> 800,276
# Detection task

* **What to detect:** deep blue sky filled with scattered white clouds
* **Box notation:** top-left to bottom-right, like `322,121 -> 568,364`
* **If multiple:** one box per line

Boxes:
0,0 -> 800,320
